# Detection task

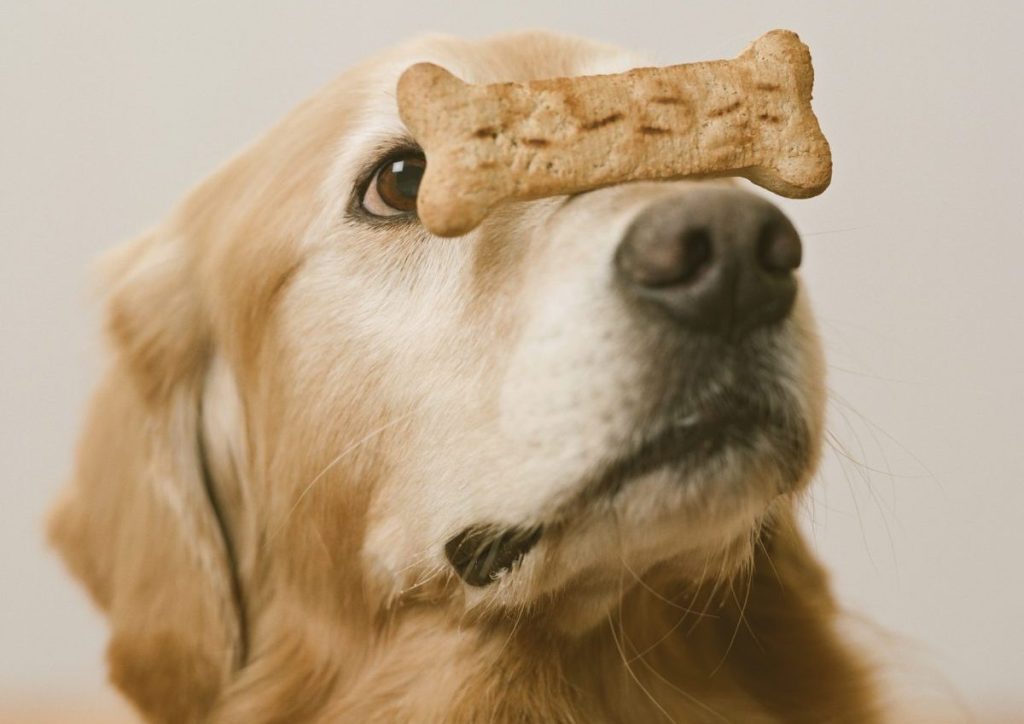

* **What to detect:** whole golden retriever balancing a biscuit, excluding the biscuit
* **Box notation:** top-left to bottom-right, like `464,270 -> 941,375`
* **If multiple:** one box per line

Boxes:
49,32 -> 882,724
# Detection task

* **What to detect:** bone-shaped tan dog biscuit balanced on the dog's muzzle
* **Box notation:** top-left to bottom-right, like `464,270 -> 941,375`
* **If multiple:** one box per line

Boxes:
398,30 -> 831,237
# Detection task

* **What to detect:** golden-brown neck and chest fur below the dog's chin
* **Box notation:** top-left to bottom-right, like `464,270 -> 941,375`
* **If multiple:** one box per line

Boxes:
214,518 -> 876,724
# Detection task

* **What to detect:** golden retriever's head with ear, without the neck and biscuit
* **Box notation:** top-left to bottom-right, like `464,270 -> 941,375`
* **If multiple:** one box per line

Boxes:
51,34 -> 823,718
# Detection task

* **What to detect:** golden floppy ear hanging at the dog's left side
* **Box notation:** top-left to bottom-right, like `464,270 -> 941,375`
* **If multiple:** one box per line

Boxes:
49,235 -> 245,722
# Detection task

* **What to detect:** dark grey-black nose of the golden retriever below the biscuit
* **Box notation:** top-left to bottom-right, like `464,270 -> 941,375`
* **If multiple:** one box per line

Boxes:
615,187 -> 802,336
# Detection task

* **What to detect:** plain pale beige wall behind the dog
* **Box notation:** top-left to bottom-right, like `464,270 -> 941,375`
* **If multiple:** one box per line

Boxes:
0,0 -> 1024,718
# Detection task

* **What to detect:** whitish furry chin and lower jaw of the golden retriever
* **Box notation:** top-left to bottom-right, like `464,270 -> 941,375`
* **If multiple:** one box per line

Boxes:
465,449 -> 802,635
